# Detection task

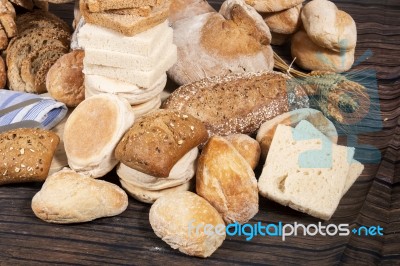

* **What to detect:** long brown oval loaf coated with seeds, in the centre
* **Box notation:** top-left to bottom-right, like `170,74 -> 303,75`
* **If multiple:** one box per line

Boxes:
162,71 -> 308,136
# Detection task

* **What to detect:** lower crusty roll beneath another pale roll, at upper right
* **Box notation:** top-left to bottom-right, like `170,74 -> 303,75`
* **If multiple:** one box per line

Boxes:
291,30 -> 354,73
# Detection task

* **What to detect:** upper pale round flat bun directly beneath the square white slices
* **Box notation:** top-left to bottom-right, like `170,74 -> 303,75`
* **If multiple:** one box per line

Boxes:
85,73 -> 167,105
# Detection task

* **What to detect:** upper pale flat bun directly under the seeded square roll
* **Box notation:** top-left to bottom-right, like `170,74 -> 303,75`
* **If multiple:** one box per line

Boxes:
117,148 -> 198,191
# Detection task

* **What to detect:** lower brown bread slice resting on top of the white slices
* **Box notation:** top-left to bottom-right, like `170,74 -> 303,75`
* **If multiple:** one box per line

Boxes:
79,0 -> 170,36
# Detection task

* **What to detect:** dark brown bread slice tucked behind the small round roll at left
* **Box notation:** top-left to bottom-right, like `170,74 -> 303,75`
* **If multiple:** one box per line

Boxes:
20,46 -> 69,93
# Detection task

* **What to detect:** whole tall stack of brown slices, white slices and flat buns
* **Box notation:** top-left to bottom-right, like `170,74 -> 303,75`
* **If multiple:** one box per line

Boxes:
77,0 -> 177,117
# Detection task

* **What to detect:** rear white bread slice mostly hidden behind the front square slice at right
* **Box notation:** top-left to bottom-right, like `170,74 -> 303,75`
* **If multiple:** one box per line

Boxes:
296,120 -> 364,195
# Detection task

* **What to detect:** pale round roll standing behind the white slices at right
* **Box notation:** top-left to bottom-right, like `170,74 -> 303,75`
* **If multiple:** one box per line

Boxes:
256,108 -> 338,159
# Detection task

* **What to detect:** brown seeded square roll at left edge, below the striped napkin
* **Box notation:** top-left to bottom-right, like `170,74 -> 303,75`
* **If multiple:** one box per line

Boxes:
0,128 -> 60,184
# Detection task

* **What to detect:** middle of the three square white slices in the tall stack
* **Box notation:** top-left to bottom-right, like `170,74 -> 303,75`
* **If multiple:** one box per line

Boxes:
83,31 -> 176,71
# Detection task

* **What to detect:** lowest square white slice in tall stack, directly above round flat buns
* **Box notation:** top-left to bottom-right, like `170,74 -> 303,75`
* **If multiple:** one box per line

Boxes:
83,46 -> 177,88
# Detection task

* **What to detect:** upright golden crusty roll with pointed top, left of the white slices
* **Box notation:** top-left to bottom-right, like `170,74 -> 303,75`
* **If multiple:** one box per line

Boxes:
196,136 -> 258,224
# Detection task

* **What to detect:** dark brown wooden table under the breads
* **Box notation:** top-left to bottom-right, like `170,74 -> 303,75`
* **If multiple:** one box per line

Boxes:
0,0 -> 400,265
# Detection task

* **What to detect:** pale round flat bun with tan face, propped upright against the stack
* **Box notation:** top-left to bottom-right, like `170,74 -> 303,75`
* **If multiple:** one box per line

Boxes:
64,94 -> 134,178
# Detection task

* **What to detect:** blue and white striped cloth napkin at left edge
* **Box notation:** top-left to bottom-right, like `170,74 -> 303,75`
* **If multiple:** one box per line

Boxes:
0,89 -> 68,129
